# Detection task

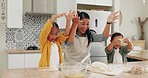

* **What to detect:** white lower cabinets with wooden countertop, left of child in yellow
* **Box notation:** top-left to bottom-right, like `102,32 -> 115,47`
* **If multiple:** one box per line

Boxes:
6,50 -> 41,69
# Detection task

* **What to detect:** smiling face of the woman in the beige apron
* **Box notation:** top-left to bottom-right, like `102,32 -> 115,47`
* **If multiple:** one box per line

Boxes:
78,18 -> 90,35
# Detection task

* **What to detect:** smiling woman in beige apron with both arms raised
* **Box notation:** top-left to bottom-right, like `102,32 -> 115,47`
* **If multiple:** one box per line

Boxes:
64,12 -> 118,62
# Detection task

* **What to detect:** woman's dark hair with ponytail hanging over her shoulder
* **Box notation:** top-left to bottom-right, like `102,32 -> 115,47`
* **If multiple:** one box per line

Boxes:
77,11 -> 93,47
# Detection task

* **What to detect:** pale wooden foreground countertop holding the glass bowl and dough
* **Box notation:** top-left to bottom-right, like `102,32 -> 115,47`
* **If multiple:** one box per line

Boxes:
2,61 -> 148,78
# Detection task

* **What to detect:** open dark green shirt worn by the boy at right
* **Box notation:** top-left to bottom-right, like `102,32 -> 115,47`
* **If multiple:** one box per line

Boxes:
105,45 -> 131,63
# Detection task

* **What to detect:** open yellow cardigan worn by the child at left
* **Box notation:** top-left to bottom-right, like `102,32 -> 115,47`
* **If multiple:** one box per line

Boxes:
39,20 -> 68,67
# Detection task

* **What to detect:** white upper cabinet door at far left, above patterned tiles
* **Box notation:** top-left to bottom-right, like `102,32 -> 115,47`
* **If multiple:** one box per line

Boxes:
7,0 -> 23,28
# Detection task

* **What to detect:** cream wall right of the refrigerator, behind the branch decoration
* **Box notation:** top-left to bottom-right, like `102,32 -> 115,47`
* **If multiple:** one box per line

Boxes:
119,0 -> 148,49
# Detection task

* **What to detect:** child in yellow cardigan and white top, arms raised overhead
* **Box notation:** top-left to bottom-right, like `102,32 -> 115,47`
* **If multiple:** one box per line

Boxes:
39,11 -> 75,67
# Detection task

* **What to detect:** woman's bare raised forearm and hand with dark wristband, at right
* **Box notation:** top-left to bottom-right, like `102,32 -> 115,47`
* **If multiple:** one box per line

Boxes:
103,11 -> 119,37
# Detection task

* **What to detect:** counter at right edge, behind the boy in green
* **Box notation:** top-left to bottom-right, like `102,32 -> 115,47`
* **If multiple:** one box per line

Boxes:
127,50 -> 148,61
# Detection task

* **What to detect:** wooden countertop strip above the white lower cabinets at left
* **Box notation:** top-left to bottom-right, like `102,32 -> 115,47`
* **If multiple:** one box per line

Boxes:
6,50 -> 41,54
